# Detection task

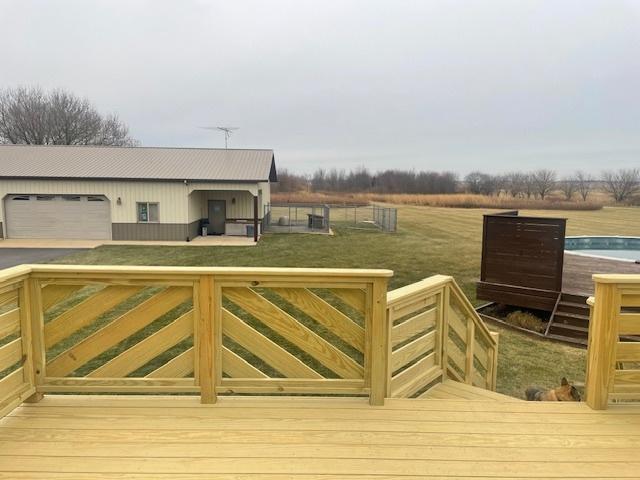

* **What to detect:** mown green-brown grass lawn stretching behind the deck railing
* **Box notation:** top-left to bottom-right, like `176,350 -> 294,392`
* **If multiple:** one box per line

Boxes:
50,205 -> 640,396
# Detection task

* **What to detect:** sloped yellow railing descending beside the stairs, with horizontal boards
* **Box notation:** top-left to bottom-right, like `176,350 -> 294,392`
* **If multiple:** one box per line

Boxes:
387,275 -> 498,397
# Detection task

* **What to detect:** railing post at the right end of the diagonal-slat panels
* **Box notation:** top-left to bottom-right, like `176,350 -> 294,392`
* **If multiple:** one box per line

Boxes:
369,278 -> 391,405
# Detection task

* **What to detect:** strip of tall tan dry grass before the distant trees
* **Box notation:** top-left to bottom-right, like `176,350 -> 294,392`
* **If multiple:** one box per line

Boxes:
271,192 -> 603,210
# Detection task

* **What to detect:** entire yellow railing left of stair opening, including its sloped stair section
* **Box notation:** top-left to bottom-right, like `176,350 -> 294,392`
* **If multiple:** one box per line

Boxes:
0,265 -> 497,410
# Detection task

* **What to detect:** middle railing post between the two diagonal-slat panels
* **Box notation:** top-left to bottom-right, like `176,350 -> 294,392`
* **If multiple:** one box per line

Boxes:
194,275 -> 216,403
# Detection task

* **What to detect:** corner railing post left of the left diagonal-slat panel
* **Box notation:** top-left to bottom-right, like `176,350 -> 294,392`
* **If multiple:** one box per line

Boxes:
20,279 -> 46,403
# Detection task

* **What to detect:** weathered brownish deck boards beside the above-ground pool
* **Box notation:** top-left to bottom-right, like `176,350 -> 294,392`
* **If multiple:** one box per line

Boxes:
562,253 -> 640,297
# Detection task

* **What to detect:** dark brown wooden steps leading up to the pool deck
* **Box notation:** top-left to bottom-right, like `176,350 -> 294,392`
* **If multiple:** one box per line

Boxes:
546,293 -> 589,345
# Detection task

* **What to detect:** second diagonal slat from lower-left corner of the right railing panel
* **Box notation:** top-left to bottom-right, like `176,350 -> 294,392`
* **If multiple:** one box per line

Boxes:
222,309 -> 323,378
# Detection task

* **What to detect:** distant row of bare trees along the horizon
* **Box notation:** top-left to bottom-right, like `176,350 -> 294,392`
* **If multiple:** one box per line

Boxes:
275,167 -> 640,202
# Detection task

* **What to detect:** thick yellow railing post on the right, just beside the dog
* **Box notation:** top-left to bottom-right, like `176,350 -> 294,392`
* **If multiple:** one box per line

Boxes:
585,280 -> 620,410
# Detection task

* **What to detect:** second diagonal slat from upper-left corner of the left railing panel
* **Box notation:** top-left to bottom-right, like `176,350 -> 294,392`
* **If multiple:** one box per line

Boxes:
44,285 -> 143,348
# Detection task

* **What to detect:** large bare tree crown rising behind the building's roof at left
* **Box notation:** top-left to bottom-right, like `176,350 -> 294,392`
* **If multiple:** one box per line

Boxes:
0,87 -> 138,146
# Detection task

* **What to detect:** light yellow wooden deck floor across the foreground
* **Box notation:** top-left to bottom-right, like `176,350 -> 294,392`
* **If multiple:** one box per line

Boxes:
0,386 -> 640,480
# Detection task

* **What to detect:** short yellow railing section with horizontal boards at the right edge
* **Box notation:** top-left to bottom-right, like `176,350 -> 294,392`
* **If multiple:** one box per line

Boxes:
585,275 -> 640,410
